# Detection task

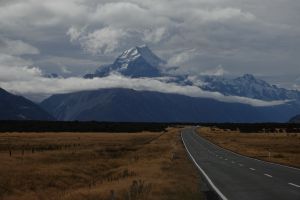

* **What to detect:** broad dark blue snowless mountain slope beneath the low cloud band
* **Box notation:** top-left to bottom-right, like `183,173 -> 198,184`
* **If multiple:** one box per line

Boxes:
41,89 -> 300,122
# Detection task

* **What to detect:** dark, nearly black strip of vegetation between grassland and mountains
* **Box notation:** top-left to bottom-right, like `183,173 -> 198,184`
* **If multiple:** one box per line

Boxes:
0,120 -> 300,133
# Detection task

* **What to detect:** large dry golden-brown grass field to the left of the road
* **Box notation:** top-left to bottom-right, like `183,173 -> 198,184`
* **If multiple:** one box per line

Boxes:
0,128 -> 201,200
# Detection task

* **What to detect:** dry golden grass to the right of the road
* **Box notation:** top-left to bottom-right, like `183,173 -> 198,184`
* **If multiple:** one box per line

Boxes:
197,127 -> 300,168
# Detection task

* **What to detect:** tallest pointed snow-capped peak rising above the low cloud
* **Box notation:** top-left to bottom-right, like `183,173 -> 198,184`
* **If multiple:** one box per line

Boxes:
85,45 -> 165,78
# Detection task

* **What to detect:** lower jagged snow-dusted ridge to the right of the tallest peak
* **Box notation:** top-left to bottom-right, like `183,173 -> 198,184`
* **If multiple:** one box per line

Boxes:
200,74 -> 300,101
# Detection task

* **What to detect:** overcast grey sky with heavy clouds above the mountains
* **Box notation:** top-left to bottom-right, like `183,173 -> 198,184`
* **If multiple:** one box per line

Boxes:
0,0 -> 300,100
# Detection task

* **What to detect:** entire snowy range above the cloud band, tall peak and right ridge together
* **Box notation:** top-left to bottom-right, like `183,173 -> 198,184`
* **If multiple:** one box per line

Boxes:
85,45 -> 300,101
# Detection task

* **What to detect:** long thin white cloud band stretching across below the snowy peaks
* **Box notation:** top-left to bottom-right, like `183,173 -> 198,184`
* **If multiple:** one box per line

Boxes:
0,74 -> 287,106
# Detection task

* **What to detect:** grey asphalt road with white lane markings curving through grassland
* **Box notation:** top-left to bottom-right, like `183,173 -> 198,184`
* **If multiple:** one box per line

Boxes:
181,128 -> 300,200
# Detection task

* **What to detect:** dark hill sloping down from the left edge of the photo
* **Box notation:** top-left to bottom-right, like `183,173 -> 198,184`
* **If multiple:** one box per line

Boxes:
0,88 -> 54,120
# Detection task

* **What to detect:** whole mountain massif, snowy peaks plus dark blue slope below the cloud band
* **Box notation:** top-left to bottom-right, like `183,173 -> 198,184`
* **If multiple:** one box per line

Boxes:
40,45 -> 300,122
